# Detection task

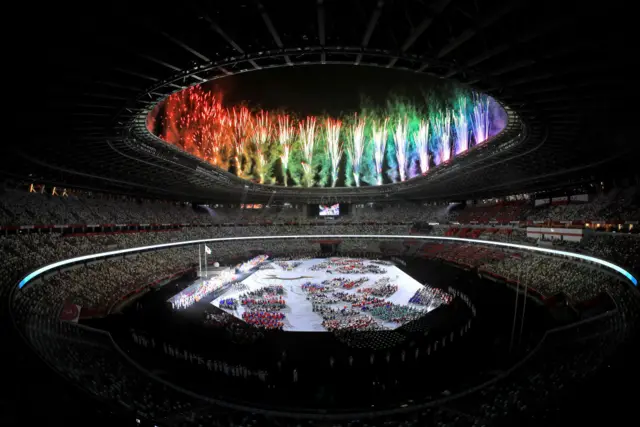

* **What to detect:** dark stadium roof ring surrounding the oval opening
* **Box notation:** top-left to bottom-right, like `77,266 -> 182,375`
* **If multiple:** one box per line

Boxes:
12,0 -> 636,202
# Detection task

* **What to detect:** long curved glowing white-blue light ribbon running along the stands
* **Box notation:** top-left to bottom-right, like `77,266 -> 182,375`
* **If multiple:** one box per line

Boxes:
18,234 -> 638,289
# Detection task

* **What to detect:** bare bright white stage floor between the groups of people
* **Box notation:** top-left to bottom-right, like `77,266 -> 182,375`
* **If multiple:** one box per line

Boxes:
211,258 -> 436,332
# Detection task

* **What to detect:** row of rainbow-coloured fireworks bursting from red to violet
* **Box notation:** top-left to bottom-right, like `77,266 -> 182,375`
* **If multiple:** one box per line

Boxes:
148,86 -> 505,187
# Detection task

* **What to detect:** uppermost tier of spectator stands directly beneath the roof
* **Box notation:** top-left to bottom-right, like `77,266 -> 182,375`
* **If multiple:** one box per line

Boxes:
0,185 -> 640,231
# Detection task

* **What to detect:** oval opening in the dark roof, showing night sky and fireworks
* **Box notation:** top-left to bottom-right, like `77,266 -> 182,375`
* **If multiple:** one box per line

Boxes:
147,65 -> 507,188
